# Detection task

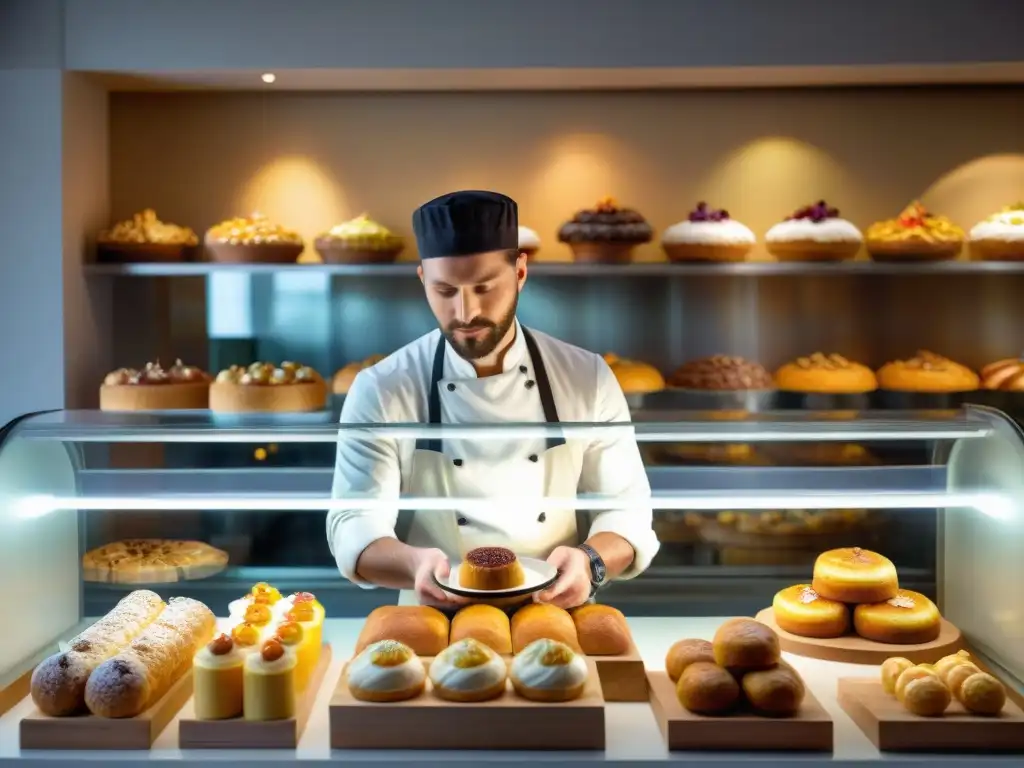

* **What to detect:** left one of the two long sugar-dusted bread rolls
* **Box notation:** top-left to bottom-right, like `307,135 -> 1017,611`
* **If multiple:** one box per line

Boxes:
32,590 -> 164,717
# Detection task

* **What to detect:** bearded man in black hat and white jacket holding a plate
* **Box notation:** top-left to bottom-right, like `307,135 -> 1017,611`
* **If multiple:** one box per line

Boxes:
327,191 -> 658,609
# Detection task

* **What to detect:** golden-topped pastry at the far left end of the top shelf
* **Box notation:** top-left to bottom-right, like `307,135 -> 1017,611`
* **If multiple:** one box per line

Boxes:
96,208 -> 199,263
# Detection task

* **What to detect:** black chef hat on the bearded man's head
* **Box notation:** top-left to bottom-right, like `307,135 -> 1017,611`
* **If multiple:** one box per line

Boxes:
413,189 -> 519,259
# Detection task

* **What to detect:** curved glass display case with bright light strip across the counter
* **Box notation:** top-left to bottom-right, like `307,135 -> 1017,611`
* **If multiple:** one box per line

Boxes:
0,407 -> 1024,765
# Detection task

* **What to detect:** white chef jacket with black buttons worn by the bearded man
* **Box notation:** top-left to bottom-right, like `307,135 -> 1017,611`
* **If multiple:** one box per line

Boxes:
327,321 -> 659,588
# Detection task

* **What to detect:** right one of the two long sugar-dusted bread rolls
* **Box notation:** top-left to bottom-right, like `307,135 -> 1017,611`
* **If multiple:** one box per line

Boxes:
85,597 -> 217,718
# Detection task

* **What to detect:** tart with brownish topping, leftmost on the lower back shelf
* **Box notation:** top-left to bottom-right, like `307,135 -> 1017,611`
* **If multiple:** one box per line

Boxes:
99,360 -> 210,411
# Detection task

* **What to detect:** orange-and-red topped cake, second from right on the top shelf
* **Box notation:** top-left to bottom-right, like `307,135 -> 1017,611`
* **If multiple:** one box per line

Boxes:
865,202 -> 964,261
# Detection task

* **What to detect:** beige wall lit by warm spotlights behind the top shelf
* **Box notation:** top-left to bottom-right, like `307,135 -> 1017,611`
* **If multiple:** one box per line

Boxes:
111,88 -> 1024,259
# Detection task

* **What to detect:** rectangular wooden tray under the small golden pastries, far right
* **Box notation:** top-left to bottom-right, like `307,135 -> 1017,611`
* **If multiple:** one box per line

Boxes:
838,677 -> 1024,752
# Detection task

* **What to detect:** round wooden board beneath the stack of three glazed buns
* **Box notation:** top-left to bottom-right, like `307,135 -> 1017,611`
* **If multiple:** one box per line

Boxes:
757,608 -> 964,665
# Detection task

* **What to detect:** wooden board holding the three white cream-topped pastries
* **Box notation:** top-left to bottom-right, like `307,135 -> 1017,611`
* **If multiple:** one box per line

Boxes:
331,658 -> 604,750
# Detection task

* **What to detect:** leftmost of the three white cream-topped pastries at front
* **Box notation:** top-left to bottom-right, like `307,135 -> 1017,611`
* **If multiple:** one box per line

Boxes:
347,640 -> 427,701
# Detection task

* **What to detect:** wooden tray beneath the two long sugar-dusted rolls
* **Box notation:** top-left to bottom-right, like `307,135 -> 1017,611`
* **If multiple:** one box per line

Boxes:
19,670 -> 193,750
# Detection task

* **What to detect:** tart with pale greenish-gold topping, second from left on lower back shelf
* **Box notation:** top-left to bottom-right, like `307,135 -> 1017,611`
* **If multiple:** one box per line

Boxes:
210,362 -> 327,414
